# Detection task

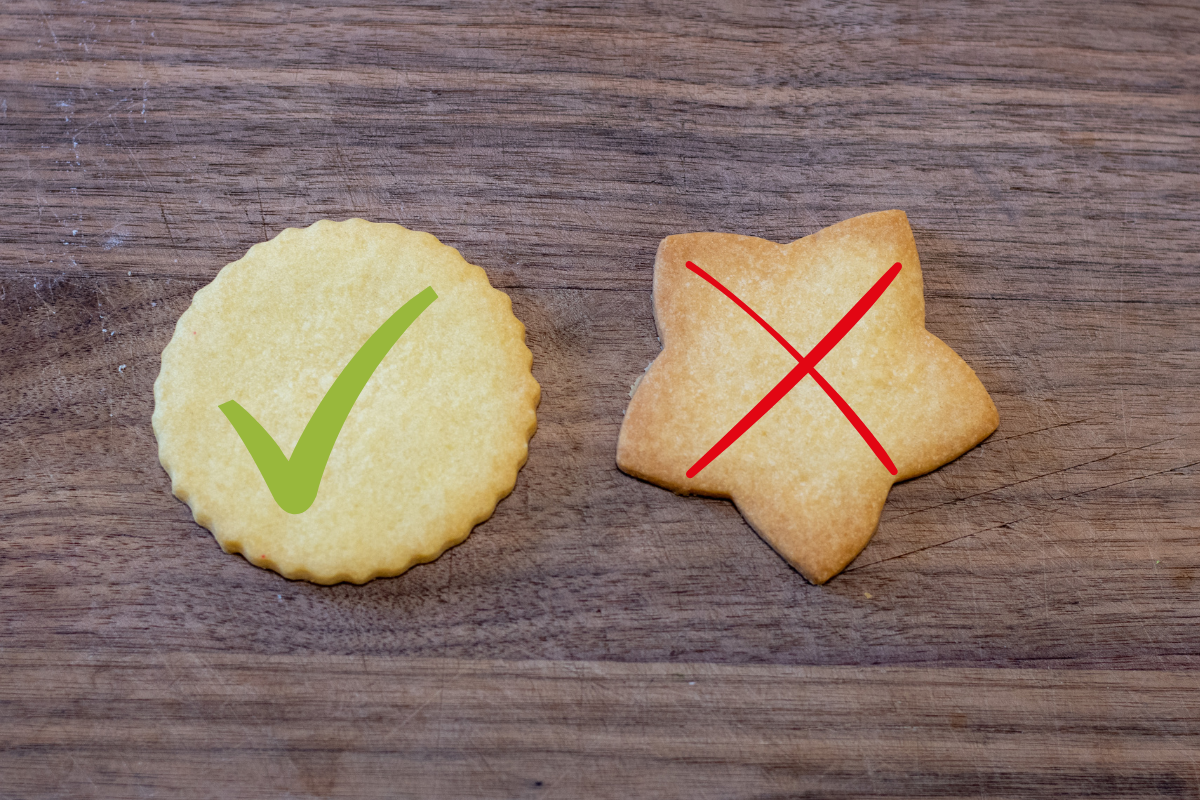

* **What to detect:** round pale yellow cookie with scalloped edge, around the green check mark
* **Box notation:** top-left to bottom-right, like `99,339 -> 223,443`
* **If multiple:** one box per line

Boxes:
152,219 -> 540,584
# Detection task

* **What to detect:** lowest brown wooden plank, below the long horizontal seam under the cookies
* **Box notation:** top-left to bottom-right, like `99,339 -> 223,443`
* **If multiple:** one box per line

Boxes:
0,652 -> 1200,798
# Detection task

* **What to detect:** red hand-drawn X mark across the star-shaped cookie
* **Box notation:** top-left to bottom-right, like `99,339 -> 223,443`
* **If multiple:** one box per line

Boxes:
688,261 -> 900,477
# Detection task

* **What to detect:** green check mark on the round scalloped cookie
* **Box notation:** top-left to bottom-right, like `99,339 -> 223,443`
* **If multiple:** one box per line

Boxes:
217,287 -> 438,513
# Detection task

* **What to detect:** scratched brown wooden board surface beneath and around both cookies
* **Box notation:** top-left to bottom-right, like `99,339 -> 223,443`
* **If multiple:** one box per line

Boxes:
0,0 -> 1200,798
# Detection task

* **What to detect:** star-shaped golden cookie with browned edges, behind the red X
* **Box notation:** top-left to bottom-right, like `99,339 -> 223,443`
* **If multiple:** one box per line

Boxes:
617,211 -> 1000,583
